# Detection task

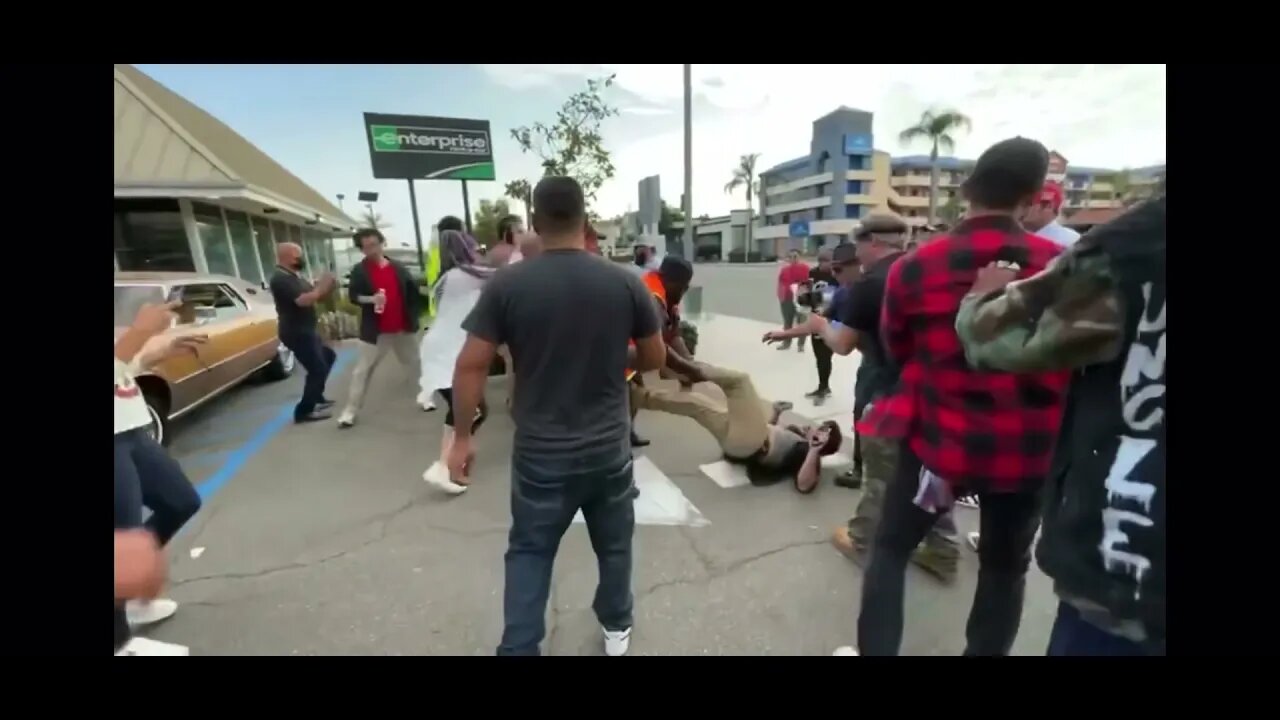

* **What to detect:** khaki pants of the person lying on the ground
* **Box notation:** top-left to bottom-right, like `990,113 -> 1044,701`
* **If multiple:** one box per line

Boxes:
631,363 -> 769,459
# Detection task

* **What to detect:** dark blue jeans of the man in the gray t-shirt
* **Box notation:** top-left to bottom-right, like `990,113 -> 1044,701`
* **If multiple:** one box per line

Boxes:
498,454 -> 639,655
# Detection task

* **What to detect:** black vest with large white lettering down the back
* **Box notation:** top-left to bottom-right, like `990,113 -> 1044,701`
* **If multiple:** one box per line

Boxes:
1037,197 -> 1166,652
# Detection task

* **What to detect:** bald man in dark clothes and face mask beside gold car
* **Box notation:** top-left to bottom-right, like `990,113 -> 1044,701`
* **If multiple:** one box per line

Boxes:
270,242 -> 338,423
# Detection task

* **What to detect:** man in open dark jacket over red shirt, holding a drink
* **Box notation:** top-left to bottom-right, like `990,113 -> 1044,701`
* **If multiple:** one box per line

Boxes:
338,228 -> 422,428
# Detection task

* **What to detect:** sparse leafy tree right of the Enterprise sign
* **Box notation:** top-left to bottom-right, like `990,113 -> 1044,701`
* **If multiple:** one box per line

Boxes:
507,76 -> 618,202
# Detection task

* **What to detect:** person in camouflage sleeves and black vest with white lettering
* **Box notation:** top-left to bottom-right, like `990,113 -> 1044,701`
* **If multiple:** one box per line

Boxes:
956,186 -> 1166,655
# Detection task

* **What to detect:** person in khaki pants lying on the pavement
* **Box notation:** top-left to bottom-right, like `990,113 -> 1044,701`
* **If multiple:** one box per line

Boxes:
631,363 -> 842,493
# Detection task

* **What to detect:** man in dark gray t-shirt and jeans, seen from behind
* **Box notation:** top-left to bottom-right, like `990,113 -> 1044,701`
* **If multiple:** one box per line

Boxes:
448,177 -> 666,655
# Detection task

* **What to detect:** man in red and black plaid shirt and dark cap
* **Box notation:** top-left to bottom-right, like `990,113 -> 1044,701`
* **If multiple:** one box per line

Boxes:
858,137 -> 1068,655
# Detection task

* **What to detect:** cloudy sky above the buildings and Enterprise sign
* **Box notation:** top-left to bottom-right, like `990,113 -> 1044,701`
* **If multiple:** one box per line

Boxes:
140,65 -> 1165,245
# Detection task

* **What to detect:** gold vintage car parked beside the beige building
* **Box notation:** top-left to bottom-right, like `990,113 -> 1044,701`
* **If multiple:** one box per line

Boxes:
115,273 -> 296,443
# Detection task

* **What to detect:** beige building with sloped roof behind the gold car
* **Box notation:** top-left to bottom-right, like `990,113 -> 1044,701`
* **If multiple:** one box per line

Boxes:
114,65 -> 355,282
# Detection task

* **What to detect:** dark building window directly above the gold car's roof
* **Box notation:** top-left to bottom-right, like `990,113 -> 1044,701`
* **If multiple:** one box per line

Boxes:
114,200 -> 196,273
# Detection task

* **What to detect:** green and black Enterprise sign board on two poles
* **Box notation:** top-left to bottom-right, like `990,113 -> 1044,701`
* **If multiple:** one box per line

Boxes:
365,113 -> 494,181
